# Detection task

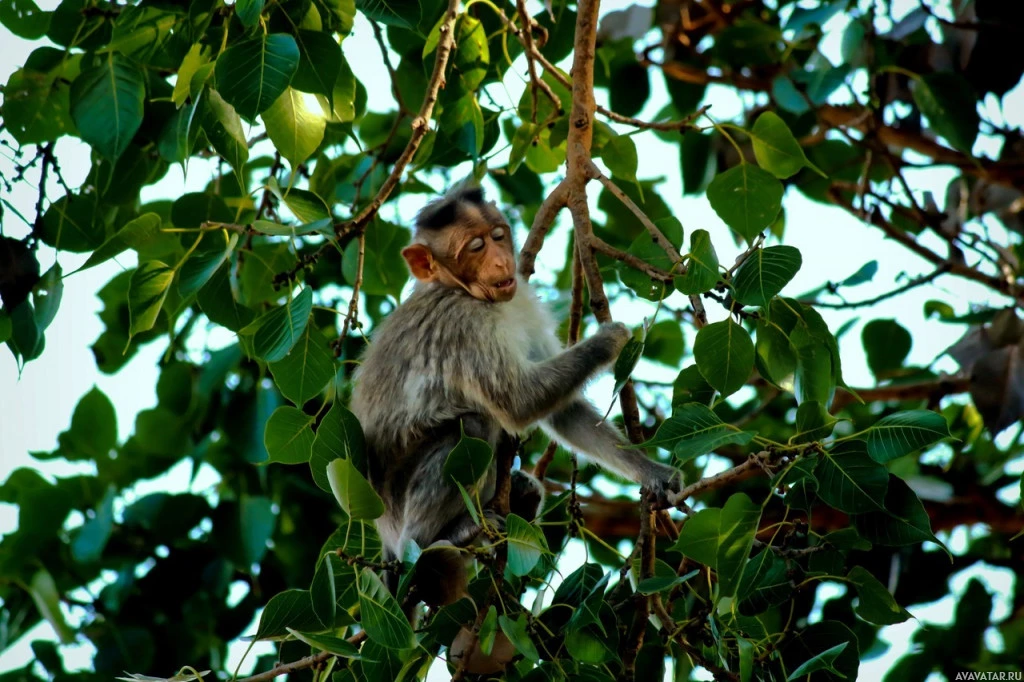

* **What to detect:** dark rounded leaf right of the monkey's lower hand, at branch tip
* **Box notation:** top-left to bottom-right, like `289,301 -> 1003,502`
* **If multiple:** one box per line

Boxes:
814,440 -> 889,514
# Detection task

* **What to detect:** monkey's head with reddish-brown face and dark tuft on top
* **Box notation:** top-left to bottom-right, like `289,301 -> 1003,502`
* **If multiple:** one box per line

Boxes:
401,187 -> 516,303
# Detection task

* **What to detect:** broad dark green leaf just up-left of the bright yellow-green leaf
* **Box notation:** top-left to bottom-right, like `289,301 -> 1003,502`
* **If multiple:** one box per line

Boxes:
214,33 -> 299,122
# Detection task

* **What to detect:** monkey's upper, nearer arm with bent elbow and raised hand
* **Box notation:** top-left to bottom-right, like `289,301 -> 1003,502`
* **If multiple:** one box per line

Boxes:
454,324 -> 630,431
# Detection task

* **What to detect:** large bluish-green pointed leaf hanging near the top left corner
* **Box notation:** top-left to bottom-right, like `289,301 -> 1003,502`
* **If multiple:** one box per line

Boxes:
71,52 -> 145,161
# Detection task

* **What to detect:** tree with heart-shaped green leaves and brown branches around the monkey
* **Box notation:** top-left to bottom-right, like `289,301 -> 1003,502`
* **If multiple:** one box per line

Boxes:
0,0 -> 1024,682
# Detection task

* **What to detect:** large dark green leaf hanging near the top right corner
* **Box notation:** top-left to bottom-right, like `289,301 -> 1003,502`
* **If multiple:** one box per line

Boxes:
911,72 -> 981,155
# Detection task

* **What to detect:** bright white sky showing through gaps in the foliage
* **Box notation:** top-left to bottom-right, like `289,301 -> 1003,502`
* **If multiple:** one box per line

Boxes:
0,0 -> 1024,679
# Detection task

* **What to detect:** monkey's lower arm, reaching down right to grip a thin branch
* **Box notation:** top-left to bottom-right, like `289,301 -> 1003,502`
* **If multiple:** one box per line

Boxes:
544,397 -> 679,494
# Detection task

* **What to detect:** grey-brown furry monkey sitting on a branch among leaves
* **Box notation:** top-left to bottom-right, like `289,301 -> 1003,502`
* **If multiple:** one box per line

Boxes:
350,186 -> 678,606
